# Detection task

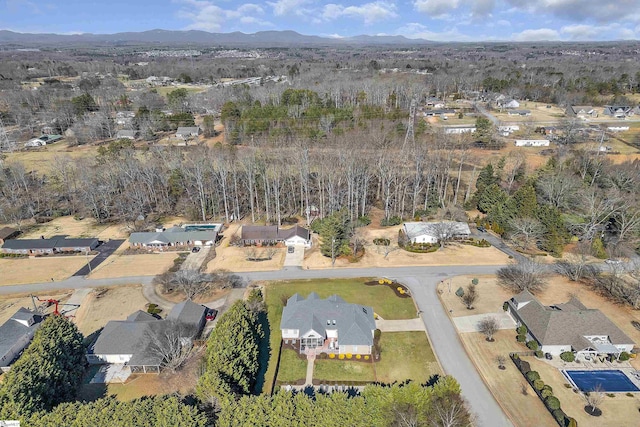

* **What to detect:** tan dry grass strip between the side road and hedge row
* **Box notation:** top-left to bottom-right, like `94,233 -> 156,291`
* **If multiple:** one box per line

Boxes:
460,330 -> 556,427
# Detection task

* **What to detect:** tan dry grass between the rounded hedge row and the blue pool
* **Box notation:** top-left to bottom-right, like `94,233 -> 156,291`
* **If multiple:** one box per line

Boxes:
524,357 -> 640,426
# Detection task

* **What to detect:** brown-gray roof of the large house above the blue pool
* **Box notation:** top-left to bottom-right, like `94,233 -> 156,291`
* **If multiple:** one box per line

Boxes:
510,291 -> 633,351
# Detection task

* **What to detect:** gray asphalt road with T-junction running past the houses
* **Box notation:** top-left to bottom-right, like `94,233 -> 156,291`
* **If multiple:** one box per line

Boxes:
0,265 -> 512,427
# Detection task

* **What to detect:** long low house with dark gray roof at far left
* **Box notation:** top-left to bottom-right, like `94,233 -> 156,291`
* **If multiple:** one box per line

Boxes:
0,236 -> 100,255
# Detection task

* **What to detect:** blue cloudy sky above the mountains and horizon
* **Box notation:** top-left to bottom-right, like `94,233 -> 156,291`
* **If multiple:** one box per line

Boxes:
0,0 -> 640,41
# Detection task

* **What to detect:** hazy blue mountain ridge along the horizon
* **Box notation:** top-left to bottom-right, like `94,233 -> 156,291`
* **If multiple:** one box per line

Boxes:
0,29 -> 429,47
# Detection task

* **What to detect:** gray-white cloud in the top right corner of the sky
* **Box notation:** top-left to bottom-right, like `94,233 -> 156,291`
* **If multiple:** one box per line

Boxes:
507,0 -> 640,23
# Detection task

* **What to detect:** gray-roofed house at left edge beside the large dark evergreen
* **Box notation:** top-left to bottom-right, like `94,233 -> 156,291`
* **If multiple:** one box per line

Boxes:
0,308 -> 43,371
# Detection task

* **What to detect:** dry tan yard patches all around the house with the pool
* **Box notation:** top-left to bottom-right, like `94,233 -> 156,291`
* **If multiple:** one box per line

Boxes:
439,276 -> 640,426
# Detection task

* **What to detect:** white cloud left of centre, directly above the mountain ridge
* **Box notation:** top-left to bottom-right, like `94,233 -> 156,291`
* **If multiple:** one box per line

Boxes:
178,0 -> 273,31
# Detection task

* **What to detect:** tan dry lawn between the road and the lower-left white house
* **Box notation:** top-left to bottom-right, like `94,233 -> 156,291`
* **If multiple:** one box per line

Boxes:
75,285 -> 148,336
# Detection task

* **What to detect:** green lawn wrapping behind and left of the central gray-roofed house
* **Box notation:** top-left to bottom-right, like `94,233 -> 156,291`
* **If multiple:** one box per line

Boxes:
263,278 -> 416,393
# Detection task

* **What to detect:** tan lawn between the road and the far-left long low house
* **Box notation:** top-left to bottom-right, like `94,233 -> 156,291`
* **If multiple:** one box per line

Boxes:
0,255 -> 93,286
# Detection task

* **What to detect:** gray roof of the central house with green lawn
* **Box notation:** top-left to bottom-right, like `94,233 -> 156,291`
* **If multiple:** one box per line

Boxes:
280,292 -> 376,346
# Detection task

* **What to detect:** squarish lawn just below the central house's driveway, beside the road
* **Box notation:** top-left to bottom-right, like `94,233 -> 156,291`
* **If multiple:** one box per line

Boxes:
376,332 -> 442,383
